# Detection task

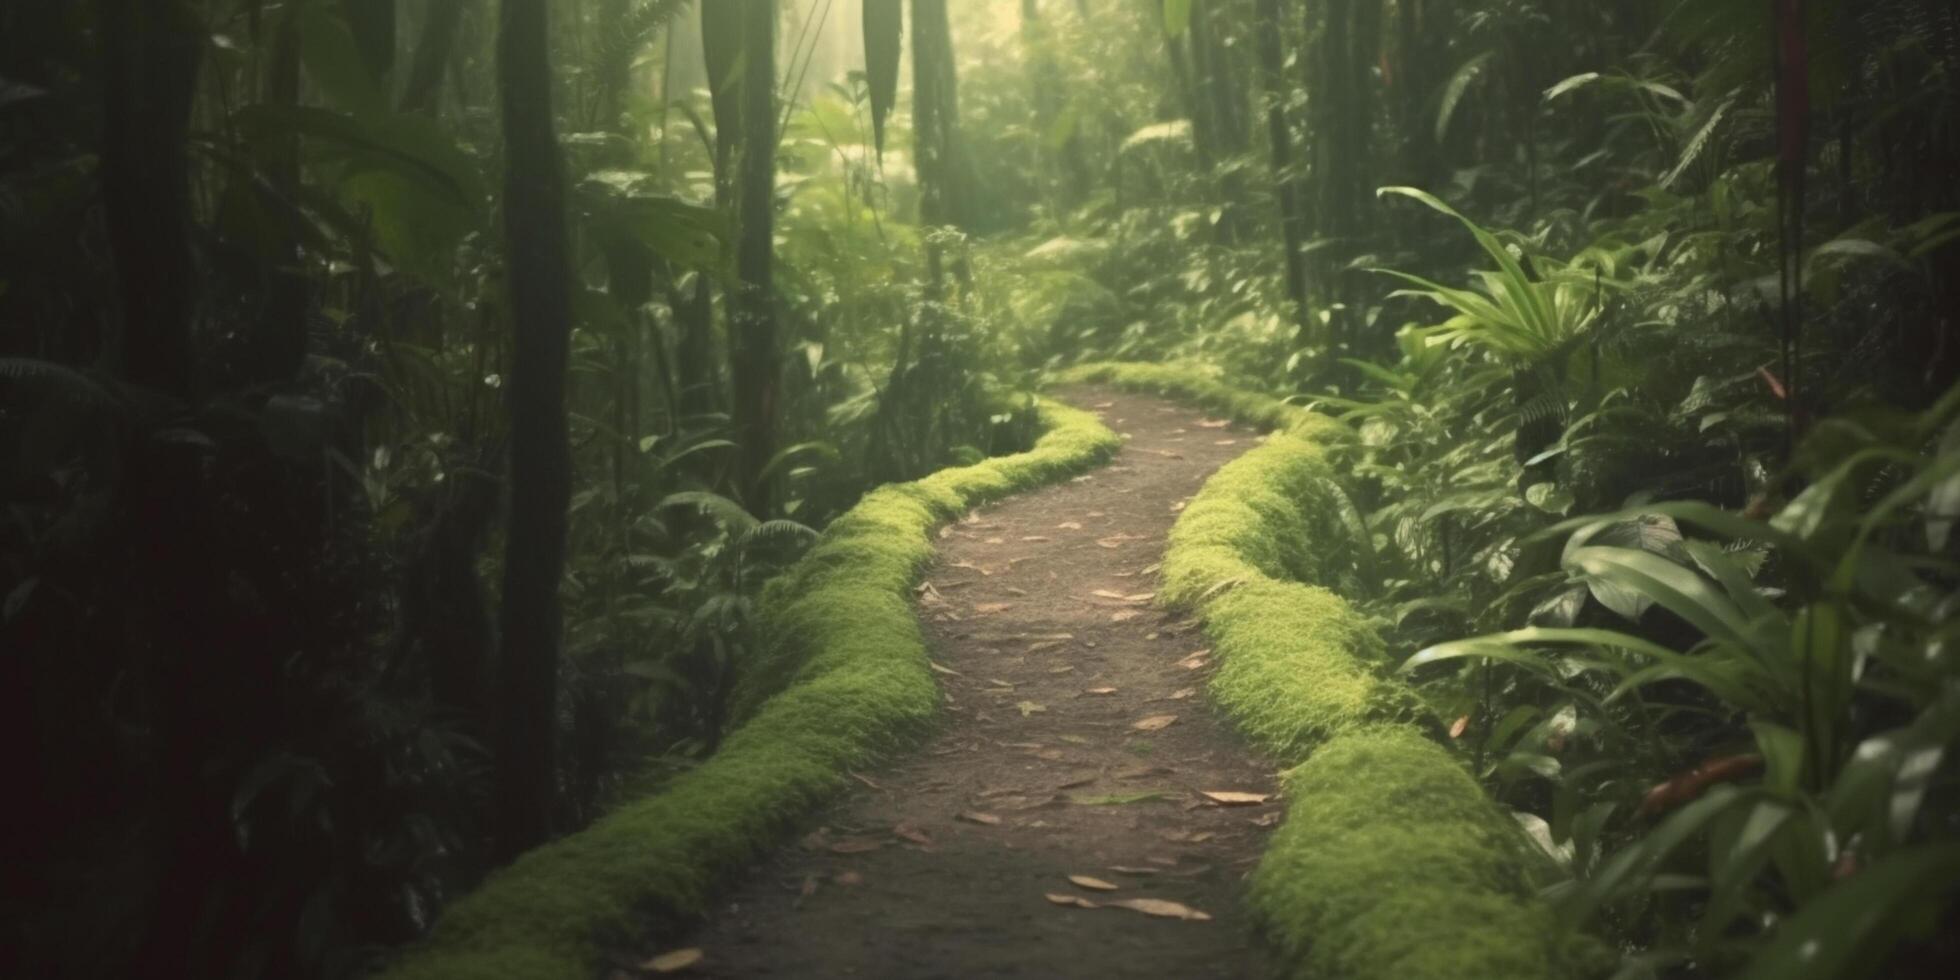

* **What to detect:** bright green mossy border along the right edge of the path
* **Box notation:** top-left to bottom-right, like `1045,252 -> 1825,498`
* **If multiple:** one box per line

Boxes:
1089,365 -> 1590,980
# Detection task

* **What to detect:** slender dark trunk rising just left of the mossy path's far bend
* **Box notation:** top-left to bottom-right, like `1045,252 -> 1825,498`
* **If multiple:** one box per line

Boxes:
729,0 -> 782,514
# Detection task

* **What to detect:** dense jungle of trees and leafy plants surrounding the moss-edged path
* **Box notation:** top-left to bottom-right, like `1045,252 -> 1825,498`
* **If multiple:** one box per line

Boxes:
0,0 -> 1960,976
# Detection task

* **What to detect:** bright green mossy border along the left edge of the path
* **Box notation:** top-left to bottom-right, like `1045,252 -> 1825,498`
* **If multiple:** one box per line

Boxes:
384,402 -> 1121,980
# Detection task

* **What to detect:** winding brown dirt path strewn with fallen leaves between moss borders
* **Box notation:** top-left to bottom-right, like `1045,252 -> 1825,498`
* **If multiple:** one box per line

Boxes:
674,388 -> 1280,978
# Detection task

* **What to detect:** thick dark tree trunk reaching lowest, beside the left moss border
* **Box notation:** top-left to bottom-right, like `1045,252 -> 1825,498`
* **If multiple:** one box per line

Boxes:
494,0 -> 572,860
